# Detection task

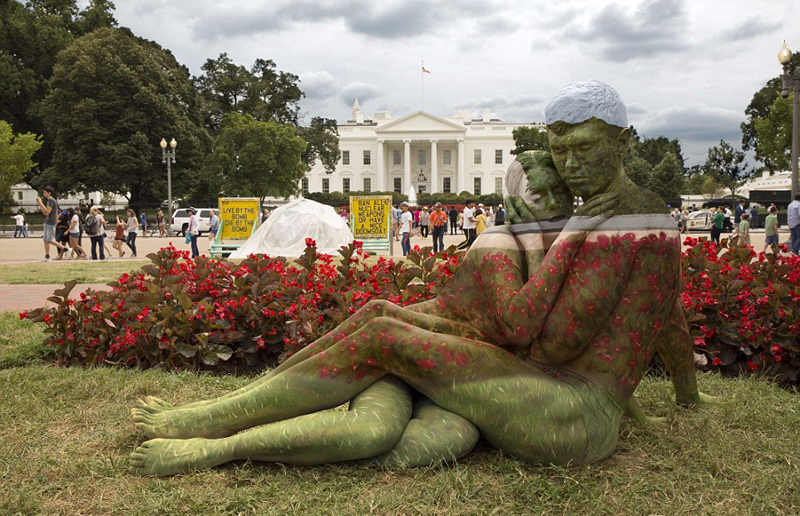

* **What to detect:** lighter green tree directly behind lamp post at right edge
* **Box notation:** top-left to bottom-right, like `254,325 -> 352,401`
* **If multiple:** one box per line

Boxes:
753,97 -> 792,170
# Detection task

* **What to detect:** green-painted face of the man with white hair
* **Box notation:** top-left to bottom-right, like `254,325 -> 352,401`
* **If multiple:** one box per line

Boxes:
547,118 -> 630,202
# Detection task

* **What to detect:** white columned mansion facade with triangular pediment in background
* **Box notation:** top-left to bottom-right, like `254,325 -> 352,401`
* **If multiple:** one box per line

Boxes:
302,100 -> 544,199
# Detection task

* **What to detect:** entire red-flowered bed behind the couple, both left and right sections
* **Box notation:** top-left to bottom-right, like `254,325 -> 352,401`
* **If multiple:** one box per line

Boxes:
20,238 -> 800,383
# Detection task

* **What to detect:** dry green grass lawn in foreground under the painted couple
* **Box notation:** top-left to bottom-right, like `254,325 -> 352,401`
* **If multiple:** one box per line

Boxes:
0,314 -> 800,516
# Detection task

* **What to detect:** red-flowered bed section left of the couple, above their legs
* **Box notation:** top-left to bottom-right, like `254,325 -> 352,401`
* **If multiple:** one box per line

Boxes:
20,239 -> 458,371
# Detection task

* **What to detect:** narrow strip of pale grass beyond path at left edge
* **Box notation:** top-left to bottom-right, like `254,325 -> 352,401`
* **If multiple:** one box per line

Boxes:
0,260 -> 150,285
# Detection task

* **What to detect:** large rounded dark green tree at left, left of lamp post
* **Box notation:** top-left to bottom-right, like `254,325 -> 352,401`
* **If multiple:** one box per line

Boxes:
44,28 -> 210,207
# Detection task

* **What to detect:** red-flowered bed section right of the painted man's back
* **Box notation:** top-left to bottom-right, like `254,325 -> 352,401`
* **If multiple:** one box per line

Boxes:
681,238 -> 800,384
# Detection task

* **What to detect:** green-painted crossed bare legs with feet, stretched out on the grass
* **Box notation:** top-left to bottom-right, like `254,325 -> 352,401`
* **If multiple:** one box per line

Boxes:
132,317 -> 586,475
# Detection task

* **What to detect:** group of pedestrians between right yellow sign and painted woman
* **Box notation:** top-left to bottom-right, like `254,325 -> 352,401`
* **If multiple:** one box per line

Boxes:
392,203 -> 505,256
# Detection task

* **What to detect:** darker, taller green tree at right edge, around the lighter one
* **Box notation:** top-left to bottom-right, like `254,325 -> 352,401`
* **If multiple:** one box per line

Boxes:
741,52 -> 800,172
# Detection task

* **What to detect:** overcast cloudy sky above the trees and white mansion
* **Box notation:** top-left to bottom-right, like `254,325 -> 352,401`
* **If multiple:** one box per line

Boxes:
103,0 -> 800,165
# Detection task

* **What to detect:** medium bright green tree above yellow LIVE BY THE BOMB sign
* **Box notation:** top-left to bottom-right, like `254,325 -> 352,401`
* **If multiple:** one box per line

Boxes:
205,112 -> 308,199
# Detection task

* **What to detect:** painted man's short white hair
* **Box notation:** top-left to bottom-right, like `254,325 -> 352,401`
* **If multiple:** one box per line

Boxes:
544,80 -> 628,127
